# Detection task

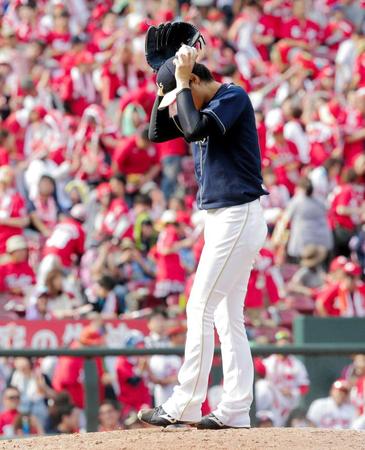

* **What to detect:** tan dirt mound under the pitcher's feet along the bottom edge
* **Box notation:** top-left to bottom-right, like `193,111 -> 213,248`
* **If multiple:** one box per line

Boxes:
0,428 -> 365,450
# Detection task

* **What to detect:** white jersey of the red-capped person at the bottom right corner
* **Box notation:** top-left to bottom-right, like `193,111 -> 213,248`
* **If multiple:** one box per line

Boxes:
307,397 -> 356,429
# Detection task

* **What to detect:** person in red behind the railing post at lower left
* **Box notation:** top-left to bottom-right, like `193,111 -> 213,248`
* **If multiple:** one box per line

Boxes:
52,325 -> 105,409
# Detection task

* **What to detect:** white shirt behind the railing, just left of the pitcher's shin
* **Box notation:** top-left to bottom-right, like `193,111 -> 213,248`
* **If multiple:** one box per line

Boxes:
150,355 -> 182,405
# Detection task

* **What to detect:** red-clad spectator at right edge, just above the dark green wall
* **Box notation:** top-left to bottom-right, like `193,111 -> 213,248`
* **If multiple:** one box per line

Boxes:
317,262 -> 365,317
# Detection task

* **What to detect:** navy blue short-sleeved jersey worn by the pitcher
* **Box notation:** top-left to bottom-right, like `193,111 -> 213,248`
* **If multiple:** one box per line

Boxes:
193,84 -> 267,209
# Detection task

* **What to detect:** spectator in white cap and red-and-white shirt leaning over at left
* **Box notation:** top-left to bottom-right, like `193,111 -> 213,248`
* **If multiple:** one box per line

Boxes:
37,204 -> 86,285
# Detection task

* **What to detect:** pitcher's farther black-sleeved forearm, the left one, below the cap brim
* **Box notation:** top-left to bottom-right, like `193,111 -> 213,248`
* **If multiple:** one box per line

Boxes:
148,96 -> 182,142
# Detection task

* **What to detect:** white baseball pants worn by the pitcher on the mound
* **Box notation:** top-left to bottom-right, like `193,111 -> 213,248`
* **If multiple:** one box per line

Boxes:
162,200 -> 267,427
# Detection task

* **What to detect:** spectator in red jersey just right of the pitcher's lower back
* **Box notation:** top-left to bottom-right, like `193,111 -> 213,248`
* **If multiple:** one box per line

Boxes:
266,123 -> 300,194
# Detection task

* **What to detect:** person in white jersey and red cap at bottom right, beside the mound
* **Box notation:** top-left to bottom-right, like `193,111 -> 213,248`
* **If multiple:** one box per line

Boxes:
307,380 -> 356,429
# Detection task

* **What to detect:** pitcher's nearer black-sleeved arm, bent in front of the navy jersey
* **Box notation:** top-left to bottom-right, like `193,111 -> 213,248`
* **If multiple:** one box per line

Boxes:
176,88 -> 214,142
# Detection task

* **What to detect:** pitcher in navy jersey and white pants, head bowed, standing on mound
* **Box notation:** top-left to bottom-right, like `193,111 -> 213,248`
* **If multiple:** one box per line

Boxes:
139,23 -> 267,429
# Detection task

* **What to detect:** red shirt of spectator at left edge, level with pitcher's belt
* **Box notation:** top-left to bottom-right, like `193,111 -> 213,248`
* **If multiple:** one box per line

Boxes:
0,189 -> 26,254
